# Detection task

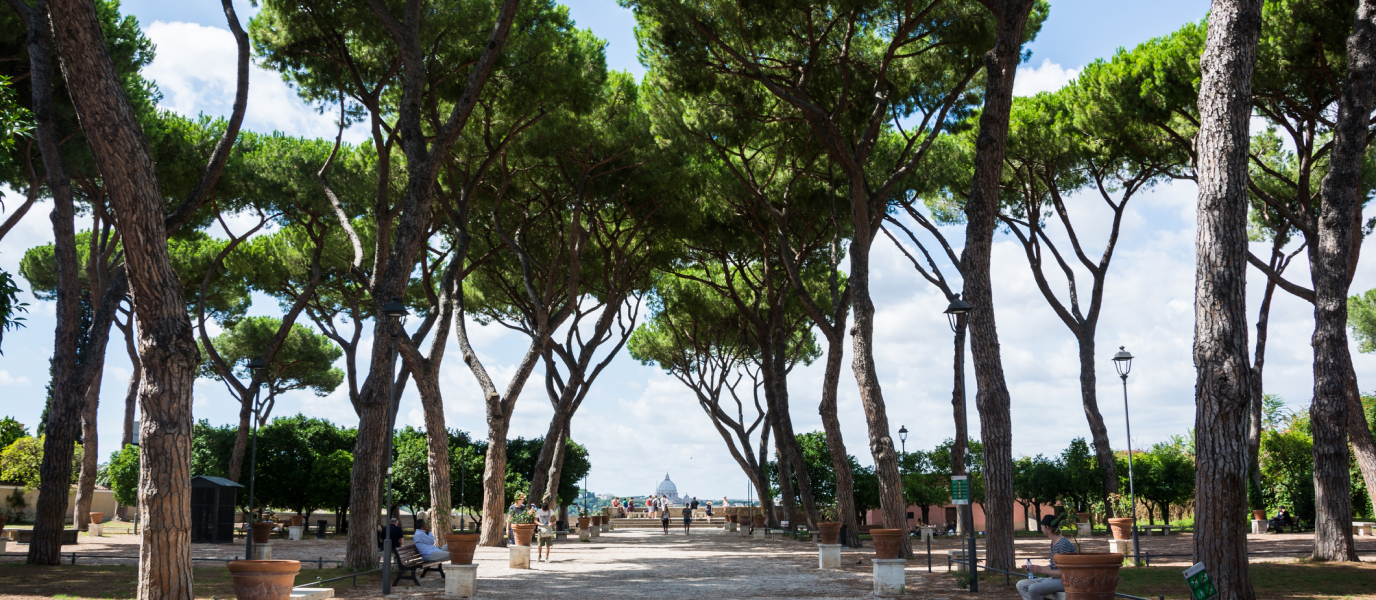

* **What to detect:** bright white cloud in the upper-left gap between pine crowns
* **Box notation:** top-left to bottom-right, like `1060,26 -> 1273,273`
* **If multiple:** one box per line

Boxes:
144,21 -> 366,142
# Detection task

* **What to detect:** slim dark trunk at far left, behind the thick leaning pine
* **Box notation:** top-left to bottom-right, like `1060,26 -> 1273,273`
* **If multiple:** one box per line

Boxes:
15,1 -> 85,564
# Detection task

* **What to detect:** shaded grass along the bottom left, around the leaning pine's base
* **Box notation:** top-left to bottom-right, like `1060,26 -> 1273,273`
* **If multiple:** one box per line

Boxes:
0,563 -> 380,600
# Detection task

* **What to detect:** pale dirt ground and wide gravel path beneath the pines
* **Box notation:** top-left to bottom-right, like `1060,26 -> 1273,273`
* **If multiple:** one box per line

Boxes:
0,526 -> 1376,600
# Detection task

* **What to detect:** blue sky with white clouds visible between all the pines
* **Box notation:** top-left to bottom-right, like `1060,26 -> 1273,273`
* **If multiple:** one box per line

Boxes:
0,0 -> 1376,497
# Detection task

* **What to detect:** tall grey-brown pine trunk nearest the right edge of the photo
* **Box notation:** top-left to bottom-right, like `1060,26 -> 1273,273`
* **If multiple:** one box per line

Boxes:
1310,0 -> 1376,561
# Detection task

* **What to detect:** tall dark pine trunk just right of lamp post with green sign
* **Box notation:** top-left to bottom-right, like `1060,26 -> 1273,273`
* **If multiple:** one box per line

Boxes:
960,0 -> 1035,570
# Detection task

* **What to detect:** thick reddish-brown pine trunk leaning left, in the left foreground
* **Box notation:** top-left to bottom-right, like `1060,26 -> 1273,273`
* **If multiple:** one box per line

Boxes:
46,0 -> 213,600
